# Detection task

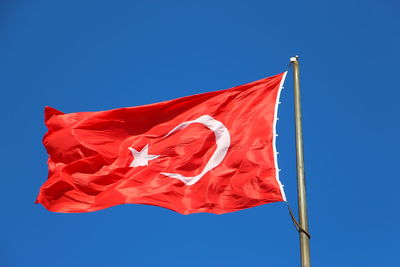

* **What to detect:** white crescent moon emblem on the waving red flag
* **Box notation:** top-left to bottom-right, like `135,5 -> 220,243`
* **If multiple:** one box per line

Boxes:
161,115 -> 231,185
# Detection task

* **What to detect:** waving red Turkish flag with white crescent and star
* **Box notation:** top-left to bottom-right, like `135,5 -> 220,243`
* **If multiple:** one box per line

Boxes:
37,73 -> 286,214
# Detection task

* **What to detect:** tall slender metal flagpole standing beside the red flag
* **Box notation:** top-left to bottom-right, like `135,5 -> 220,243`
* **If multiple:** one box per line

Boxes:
290,56 -> 311,267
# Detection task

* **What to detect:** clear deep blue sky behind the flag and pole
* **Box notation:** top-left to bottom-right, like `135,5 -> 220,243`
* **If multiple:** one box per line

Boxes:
0,0 -> 400,267
